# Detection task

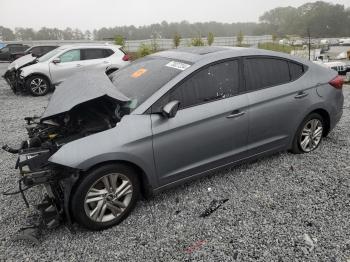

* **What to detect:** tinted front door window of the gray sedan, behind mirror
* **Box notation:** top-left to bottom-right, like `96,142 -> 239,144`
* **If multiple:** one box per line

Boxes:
153,60 -> 239,112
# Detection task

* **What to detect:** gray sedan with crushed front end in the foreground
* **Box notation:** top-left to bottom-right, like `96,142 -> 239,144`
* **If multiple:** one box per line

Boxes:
5,47 -> 344,230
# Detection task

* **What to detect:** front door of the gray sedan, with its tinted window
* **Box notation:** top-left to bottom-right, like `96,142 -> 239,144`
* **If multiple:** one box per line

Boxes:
151,60 -> 248,185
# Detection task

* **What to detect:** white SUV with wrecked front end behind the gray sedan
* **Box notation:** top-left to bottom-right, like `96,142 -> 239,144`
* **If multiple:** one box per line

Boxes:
4,44 -> 130,96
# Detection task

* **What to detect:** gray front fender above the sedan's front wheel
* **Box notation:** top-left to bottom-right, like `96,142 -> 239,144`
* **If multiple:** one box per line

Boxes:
49,115 -> 158,186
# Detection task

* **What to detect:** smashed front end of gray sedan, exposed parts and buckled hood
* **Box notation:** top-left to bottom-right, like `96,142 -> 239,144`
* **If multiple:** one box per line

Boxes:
2,71 -> 130,242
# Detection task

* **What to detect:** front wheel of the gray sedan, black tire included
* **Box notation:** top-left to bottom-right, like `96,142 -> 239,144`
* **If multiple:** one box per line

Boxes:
70,164 -> 140,230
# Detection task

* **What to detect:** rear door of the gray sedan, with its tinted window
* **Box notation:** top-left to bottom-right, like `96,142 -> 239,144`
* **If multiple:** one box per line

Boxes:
244,56 -> 313,154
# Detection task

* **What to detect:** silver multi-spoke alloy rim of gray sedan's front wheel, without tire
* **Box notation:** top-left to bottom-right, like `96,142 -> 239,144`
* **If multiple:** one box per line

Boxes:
84,173 -> 133,222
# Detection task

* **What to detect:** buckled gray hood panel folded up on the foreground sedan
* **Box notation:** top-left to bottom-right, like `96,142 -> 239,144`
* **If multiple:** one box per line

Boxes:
40,71 -> 130,121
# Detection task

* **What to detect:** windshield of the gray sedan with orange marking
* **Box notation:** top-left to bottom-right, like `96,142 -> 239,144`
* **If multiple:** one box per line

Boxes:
109,57 -> 190,110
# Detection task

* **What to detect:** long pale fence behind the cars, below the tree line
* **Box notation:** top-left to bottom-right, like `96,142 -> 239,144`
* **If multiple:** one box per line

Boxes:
2,35 -> 272,52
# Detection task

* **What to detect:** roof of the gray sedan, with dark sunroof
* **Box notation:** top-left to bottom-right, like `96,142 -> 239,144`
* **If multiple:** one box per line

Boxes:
151,46 -> 305,64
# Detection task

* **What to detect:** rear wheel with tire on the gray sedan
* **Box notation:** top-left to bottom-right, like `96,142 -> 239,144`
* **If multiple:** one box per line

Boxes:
291,113 -> 325,154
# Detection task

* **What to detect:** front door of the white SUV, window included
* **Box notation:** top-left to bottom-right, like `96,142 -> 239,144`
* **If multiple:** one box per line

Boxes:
49,49 -> 82,84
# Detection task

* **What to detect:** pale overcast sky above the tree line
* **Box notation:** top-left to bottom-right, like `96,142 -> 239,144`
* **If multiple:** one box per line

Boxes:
0,0 -> 350,30
